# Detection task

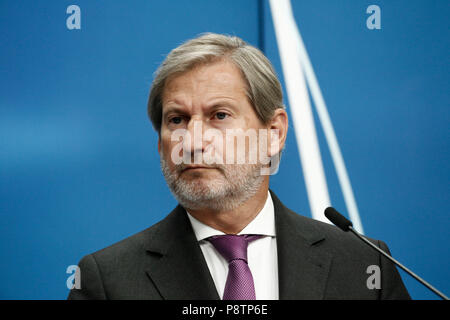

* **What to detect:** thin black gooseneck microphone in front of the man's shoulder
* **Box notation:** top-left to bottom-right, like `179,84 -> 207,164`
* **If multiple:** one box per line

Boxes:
325,207 -> 449,300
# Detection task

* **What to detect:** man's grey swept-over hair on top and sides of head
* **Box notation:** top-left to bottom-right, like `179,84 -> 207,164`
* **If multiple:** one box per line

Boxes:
147,33 -> 284,133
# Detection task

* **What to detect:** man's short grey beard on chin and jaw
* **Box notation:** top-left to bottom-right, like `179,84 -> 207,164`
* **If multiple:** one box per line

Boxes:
160,156 -> 264,211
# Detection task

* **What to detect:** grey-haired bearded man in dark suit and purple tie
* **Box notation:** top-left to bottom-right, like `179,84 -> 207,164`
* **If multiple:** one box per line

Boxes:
69,34 -> 409,299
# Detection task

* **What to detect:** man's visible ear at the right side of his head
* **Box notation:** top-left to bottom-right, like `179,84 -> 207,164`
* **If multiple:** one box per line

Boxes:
268,108 -> 289,157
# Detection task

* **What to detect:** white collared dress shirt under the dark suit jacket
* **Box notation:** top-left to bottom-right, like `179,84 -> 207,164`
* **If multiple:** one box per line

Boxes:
187,192 -> 278,300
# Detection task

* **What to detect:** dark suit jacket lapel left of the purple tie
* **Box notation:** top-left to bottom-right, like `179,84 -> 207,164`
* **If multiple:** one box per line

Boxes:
146,206 -> 219,300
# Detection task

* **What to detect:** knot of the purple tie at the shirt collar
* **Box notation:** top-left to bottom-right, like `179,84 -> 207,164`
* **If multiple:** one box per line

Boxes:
207,234 -> 263,262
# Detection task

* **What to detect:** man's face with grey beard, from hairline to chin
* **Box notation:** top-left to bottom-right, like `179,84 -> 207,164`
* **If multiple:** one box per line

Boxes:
158,61 -> 266,209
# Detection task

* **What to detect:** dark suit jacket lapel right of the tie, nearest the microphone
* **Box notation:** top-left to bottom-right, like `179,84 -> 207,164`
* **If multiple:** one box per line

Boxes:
271,191 -> 332,300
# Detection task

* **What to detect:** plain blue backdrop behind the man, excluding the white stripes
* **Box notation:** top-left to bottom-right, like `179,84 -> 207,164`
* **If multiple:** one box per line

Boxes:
0,0 -> 450,299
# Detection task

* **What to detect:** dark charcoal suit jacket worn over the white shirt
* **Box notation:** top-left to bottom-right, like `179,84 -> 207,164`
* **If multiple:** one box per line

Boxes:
68,191 -> 410,300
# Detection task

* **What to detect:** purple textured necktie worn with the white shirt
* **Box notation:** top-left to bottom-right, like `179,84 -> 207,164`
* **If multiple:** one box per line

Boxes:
207,234 -> 263,300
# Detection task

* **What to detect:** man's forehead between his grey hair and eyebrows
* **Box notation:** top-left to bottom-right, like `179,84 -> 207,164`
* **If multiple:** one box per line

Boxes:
162,60 -> 247,103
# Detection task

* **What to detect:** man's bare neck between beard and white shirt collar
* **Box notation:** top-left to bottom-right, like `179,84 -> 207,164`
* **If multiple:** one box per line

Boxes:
188,177 -> 269,234
